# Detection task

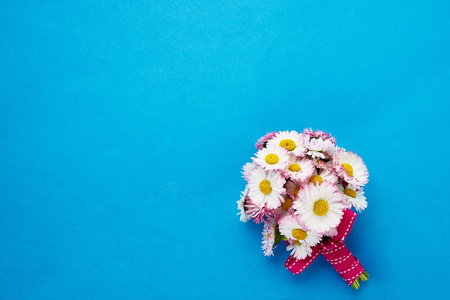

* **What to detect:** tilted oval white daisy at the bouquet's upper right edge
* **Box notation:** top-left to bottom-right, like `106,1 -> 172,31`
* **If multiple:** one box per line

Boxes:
332,148 -> 369,187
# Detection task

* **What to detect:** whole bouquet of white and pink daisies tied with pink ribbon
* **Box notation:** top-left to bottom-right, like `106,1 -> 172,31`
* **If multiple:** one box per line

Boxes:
237,129 -> 369,289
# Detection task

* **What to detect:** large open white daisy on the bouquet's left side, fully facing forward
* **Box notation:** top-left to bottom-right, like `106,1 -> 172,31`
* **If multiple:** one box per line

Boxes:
248,168 -> 286,210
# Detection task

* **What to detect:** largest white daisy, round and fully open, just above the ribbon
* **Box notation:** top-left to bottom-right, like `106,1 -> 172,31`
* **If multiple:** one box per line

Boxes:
293,181 -> 345,232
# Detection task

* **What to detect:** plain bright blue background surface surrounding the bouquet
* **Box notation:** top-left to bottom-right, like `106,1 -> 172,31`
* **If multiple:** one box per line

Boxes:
0,0 -> 450,299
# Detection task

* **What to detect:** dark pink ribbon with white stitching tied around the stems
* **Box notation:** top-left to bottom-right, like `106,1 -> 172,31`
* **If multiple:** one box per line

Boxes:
285,209 -> 369,289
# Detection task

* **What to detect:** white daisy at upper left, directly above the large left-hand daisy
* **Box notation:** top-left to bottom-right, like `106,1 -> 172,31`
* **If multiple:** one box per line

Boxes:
252,145 -> 289,171
